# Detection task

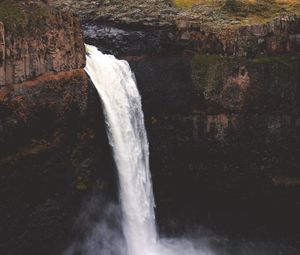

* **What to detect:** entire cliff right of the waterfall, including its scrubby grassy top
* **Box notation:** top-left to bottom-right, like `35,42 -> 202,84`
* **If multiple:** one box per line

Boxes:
50,0 -> 300,240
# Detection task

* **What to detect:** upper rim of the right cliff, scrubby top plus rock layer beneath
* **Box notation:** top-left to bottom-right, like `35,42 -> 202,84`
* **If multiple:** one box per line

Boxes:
50,0 -> 300,57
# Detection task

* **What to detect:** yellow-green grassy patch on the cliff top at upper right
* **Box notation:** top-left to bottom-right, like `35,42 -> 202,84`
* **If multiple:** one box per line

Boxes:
174,0 -> 300,27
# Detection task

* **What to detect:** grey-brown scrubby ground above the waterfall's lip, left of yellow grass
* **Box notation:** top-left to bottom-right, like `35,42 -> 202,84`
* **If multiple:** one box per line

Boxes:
49,0 -> 179,26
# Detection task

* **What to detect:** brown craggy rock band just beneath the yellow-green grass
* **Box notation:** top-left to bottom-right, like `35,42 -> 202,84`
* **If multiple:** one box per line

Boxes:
176,15 -> 300,57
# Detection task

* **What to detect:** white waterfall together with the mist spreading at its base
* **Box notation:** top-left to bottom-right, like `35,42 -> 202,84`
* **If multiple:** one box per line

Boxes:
64,45 -> 294,255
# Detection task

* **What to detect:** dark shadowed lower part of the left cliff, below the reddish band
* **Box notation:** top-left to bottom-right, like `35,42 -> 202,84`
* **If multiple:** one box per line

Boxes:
0,78 -> 116,255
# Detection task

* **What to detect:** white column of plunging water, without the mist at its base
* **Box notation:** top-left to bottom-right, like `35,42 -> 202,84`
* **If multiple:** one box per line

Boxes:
85,45 -> 157,255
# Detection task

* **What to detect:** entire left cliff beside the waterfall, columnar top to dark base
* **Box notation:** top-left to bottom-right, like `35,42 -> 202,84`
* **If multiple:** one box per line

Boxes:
0,0 -> 115,255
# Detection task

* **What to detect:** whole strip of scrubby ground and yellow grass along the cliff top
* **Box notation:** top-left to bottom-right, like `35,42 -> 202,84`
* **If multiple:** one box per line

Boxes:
49,0 -> 300,28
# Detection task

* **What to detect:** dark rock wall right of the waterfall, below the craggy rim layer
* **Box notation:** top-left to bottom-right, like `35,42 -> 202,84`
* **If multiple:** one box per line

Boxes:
130,54 -> 300,240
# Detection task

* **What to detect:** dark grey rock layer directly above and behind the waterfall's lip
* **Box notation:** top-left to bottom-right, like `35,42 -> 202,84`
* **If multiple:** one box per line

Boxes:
84,22 -> 178,56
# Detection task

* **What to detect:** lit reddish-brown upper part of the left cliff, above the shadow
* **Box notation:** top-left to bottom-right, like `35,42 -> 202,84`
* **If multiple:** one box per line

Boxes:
0,1 -> 88,151
